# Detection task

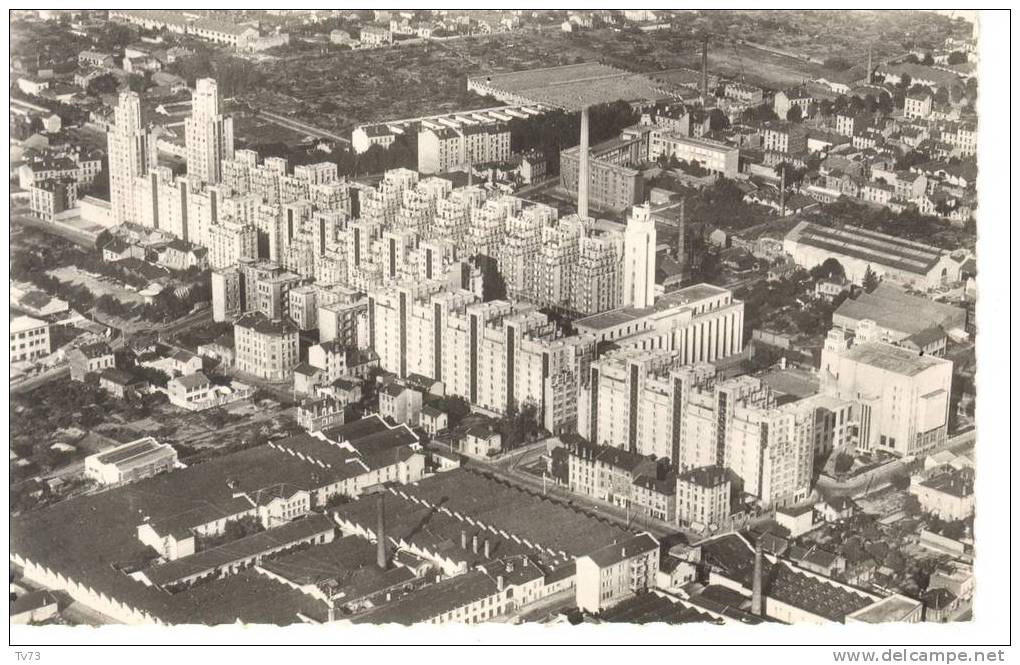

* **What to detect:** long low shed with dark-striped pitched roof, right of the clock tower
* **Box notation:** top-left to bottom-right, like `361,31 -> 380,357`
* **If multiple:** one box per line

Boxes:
782,221 -> 960,291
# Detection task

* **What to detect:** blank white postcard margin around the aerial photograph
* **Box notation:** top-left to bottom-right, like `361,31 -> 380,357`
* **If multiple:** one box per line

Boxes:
4,1 -> 1016,652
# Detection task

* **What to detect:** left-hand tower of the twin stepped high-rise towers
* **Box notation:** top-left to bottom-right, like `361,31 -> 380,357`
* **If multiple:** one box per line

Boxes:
106,90 -> 156,224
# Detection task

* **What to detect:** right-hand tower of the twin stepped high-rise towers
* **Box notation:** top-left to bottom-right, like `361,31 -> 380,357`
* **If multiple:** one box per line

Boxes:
185,79 -> 234,185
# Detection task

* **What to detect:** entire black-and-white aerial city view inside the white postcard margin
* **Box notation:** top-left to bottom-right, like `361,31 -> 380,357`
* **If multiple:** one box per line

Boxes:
9,9 -> 979,630
